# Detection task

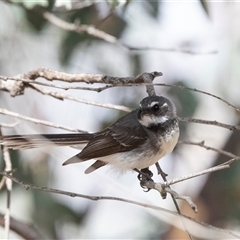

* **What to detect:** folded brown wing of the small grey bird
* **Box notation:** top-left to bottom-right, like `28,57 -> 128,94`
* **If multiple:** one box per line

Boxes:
63,111 -> 147,165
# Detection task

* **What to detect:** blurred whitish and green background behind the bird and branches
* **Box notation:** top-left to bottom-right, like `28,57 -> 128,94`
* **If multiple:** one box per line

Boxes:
0,0 -> 240,239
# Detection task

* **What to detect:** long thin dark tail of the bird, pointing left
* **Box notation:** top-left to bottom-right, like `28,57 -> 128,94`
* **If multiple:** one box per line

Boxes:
0,133 -> 92,149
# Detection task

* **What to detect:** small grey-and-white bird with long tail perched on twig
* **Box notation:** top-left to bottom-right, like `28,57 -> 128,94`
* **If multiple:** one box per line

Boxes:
0,96 -> 179,173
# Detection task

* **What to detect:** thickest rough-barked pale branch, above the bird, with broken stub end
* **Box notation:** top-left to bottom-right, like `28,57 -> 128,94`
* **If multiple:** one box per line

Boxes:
0,68 -> 162,96
